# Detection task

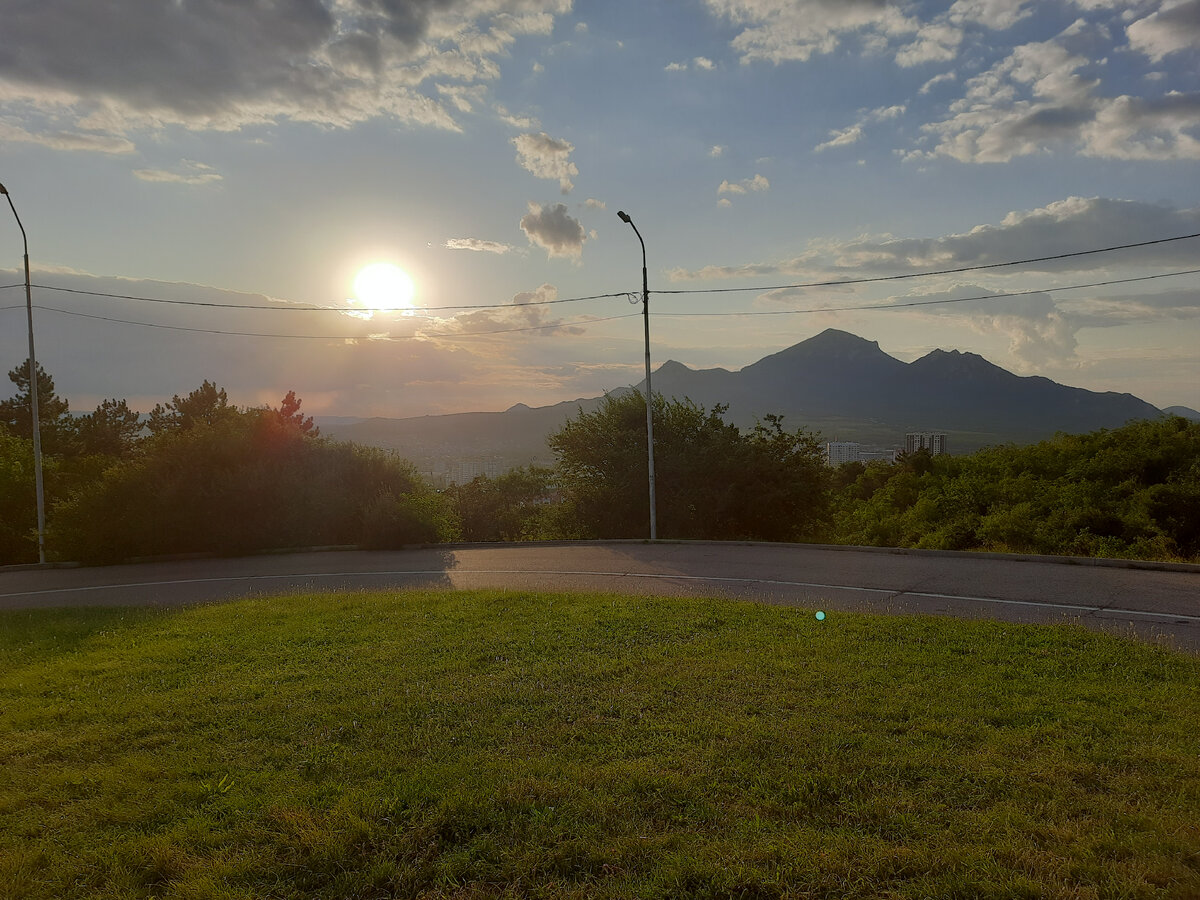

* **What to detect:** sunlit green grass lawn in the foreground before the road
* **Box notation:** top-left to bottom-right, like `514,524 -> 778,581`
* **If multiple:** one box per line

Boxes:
0,592 -> 1200,899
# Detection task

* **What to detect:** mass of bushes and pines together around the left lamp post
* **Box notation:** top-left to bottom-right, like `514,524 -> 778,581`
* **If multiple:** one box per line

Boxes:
0,370 -> 458,564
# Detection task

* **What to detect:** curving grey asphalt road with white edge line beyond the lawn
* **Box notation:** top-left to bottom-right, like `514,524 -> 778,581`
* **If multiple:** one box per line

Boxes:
0,541 -> 1200,653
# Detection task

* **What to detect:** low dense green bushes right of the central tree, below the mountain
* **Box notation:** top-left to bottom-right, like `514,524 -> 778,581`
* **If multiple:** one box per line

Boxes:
834,416 -> 1200,559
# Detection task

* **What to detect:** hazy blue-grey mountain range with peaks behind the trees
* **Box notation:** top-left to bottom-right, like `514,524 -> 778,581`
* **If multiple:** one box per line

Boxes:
322,329 -> 1166,464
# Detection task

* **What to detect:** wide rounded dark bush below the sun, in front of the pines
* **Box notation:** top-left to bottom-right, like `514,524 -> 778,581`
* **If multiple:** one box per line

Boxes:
53,410 -> 452,563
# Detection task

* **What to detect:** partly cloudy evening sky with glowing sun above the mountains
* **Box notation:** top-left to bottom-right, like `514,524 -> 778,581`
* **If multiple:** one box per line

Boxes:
0,0 -> 1200,426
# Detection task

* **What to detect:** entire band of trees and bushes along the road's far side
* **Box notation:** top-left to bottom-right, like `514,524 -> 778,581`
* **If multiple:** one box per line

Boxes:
0,355 -> 1200,565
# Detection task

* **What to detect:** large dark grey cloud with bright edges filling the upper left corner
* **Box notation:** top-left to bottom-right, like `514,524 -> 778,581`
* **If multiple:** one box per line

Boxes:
0,0 -> 571,152
